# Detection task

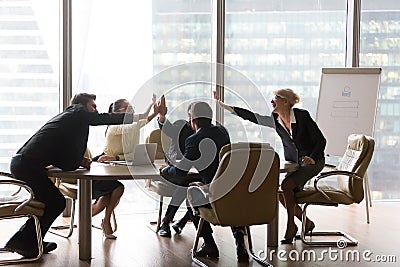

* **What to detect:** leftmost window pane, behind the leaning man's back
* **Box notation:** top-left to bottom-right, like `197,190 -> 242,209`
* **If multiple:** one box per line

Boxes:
0,0 -> 60,171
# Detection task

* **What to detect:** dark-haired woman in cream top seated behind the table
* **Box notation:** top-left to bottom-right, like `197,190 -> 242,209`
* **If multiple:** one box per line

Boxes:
92,95 -> 158,239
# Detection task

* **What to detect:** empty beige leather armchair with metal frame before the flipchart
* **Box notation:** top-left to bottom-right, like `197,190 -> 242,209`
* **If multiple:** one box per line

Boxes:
296,134 -> 375,246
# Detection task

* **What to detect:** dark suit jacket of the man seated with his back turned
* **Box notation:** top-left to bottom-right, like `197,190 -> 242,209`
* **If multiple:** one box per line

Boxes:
162,126 -> 230,184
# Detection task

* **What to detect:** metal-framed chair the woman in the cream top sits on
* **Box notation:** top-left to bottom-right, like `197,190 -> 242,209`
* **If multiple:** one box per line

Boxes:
49,148 -> 117,238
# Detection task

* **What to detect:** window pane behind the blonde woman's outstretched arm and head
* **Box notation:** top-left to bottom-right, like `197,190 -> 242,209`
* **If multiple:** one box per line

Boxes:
225,0 -> 347,162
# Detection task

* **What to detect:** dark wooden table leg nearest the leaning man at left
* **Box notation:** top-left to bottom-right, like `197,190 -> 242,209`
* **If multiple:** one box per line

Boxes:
78,179 -> 92,260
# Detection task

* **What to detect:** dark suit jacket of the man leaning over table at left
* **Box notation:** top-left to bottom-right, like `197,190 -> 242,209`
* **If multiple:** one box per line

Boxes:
17,105 -> 133,171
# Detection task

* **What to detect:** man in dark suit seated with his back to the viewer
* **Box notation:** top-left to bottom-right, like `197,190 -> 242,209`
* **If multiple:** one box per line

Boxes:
160,102 -> 249,261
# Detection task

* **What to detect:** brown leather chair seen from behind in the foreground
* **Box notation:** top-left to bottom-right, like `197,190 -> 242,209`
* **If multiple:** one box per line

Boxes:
188,143 -> 280,266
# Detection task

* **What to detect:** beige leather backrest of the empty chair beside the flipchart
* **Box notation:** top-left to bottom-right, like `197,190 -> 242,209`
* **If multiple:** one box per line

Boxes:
337,134 -> 375,203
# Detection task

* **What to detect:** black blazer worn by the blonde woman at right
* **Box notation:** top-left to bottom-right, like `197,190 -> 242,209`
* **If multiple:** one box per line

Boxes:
233,107 -> 326,163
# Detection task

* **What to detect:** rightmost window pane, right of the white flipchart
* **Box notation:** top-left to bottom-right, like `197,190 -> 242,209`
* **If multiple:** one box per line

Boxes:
360,0 -> 400,199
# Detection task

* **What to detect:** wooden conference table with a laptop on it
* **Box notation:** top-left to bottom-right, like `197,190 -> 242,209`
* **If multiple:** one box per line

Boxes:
47,160 -> 298,260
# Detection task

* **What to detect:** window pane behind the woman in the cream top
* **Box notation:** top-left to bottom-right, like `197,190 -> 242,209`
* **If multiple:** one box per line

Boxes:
72,0 -> 216,212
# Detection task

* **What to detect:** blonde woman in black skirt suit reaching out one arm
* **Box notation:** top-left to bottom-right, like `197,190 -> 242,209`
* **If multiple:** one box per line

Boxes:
214,88 -> 326,244
